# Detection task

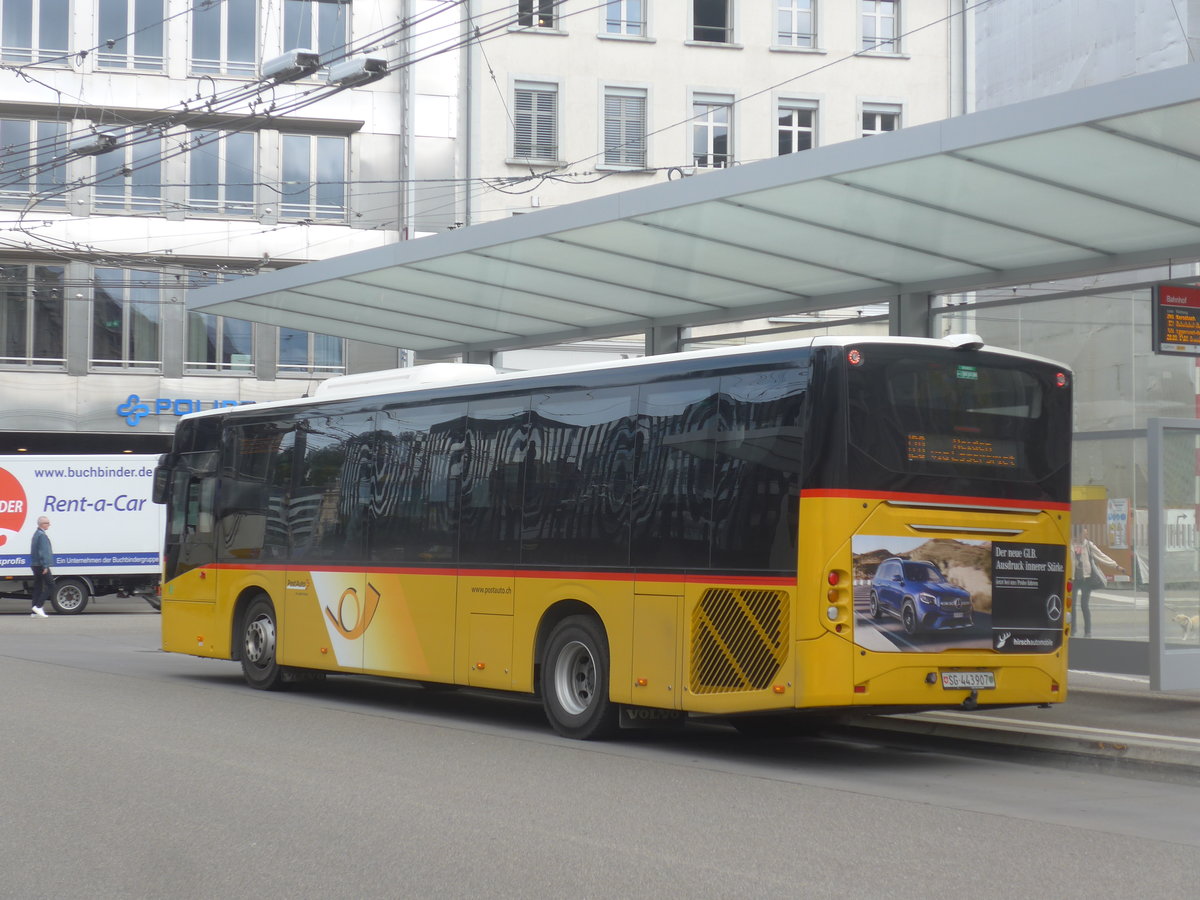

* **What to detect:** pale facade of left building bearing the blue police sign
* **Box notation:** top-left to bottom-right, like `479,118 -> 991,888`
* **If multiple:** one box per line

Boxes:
0,0 -> 417,452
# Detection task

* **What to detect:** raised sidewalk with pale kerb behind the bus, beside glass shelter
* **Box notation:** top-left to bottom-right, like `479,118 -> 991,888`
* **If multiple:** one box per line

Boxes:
851,672 -> 1200,782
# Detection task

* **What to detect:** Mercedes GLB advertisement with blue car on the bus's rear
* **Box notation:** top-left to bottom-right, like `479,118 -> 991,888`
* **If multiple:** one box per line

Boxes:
853,534 -> 1066,653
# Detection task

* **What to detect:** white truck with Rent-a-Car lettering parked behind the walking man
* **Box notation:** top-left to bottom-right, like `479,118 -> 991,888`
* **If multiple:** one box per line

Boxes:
0,454 -> 166,614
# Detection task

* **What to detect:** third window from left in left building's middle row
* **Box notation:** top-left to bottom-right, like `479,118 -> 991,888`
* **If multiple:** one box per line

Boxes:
187,131 -> 256,216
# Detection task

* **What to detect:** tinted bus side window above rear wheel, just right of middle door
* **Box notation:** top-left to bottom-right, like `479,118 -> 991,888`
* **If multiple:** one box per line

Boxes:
521,388 -> 636,566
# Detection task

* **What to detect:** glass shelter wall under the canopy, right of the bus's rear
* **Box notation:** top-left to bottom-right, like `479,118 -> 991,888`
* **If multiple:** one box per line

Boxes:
934,285 -> 1200,674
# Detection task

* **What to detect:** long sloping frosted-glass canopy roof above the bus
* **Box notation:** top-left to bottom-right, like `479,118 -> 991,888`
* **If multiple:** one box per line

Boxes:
188,64 -> 1200,356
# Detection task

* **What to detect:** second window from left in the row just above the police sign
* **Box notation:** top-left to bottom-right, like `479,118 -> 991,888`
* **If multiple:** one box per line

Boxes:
91,269 -> 162,368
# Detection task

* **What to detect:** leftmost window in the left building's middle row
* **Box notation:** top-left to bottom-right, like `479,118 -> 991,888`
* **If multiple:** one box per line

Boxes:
0,119 -> 67,209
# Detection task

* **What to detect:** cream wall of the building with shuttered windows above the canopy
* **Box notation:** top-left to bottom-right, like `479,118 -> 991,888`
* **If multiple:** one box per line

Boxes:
460,0 -> 962,223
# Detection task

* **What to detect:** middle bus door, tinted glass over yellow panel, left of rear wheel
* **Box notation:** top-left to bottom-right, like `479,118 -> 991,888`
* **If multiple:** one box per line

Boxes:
455,396 -> 530,688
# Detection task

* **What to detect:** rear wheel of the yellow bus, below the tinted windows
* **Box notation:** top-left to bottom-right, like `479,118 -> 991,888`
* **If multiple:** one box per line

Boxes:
541,616 -> 618,740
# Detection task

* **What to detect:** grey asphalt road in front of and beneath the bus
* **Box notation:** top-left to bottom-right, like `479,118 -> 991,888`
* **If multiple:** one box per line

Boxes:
0,609 -> 1200,898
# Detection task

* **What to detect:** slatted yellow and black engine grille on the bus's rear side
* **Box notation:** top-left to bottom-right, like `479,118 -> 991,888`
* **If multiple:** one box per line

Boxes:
689,588 -> 790,694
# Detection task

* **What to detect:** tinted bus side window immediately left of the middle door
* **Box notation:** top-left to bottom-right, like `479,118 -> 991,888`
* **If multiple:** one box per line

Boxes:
371,403 -> 467,563
